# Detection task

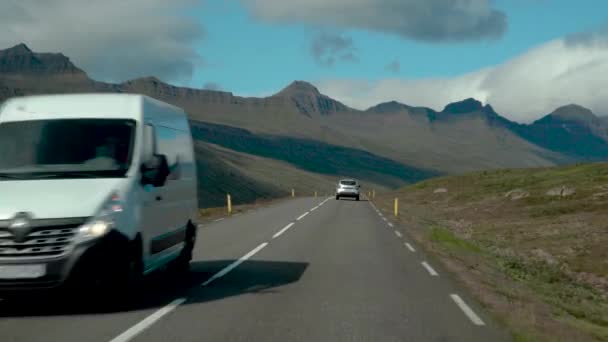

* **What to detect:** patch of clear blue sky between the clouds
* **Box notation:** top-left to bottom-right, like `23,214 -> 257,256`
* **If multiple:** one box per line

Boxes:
192,0 -> 608,95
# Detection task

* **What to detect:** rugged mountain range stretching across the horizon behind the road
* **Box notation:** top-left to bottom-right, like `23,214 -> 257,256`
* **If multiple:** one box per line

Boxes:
0,44 -> 608,206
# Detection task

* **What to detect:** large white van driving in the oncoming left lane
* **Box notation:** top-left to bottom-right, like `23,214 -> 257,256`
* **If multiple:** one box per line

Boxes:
0,94 -> 198,297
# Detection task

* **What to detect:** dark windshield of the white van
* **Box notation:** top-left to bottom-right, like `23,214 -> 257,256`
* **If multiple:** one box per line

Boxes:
0,119 -> 135,180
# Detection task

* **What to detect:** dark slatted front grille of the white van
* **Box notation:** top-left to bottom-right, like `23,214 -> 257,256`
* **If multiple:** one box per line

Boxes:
0,218 -> 86,258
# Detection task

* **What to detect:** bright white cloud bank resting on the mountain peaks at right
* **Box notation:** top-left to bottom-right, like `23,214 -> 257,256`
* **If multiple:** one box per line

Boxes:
318,34 -> 608,122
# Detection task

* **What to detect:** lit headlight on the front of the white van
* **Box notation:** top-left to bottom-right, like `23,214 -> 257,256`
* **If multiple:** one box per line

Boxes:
76,194 -> 123,243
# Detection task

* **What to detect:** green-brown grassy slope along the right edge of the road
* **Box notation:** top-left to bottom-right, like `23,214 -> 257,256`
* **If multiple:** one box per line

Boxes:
376,164 -> 608,341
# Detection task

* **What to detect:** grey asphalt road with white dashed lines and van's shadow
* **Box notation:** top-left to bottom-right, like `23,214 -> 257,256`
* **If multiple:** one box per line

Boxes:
0,198 -> 510,342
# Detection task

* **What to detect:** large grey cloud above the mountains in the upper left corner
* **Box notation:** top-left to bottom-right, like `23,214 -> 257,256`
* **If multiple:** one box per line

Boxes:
0,0 -> 204,81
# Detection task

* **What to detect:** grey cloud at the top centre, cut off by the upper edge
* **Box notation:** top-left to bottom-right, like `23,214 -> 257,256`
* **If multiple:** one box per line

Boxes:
241,0 -> 507,41
